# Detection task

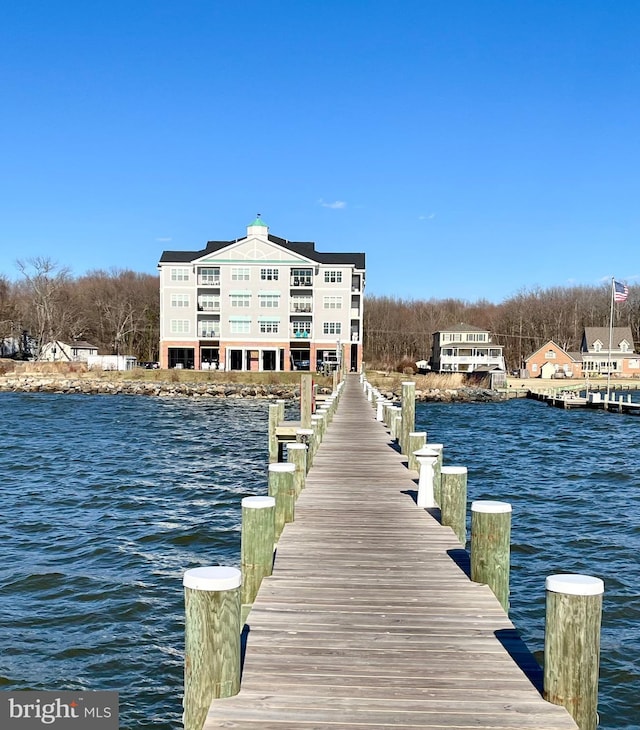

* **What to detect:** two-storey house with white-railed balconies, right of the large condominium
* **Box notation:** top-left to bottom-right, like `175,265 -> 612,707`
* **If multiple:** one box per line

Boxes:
430,323 -> 505,373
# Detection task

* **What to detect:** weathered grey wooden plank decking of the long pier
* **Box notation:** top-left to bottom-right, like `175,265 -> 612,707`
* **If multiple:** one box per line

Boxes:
205,376 -> 576,730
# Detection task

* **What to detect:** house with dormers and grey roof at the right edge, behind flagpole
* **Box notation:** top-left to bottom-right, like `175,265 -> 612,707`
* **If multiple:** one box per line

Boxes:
580,327 -> 640,378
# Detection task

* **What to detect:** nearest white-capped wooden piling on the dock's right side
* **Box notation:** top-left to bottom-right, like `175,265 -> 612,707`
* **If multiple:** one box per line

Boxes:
544,574 -> 604,730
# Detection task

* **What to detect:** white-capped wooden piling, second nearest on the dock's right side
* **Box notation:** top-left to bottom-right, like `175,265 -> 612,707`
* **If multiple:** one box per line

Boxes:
471,500 -> 511,613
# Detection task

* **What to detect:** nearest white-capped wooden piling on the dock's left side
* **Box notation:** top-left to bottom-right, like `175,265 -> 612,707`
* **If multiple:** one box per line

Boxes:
182,566 -> 242,730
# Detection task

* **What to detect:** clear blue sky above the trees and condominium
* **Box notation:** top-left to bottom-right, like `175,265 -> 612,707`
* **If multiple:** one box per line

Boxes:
0,0 -> 640,302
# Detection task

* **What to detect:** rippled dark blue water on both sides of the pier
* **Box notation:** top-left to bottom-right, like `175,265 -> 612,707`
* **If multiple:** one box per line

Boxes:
0,394 -> 640,730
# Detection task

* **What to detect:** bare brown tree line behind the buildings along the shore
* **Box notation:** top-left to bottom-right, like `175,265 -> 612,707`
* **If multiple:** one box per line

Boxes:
0,257 -> 640,370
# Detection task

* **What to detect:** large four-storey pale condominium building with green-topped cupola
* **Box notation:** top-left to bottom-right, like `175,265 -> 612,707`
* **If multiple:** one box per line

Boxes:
158,217 -> 365,371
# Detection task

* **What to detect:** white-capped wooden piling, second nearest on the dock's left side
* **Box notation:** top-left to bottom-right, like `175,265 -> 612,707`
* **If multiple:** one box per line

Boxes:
240,497 -> 276,608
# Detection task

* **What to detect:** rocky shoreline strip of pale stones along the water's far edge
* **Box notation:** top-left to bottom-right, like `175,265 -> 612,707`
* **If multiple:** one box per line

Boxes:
0,373 -> 506,403
